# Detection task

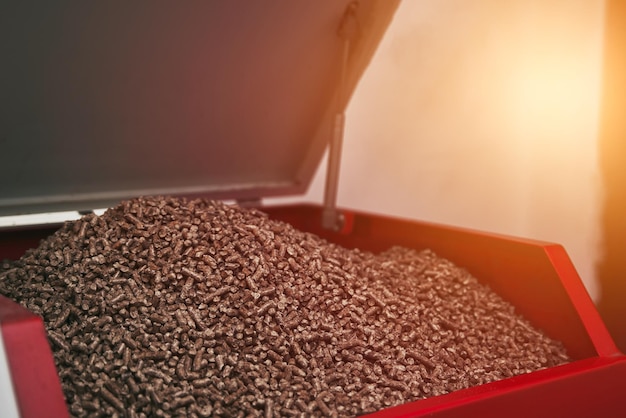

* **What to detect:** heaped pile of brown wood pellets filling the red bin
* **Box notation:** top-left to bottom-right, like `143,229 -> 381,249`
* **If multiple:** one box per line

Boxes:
0,198 -> 568,417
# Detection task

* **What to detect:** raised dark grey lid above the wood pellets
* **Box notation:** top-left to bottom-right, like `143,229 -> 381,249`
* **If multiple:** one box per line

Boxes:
0,0 -> 398,215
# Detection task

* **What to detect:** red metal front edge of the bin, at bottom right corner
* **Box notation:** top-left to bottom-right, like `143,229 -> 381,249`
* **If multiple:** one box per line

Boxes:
367,356 -> 626,418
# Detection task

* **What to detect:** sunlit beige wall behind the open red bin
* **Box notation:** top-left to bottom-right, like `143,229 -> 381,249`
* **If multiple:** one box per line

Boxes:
272,0 -> 604,299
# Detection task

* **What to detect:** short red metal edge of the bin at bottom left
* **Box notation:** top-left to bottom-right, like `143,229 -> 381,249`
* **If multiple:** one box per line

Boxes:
0,295 -> 69,418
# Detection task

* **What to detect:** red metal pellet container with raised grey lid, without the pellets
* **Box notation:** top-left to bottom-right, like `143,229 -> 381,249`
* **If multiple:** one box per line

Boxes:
0,1 -> 626,416
